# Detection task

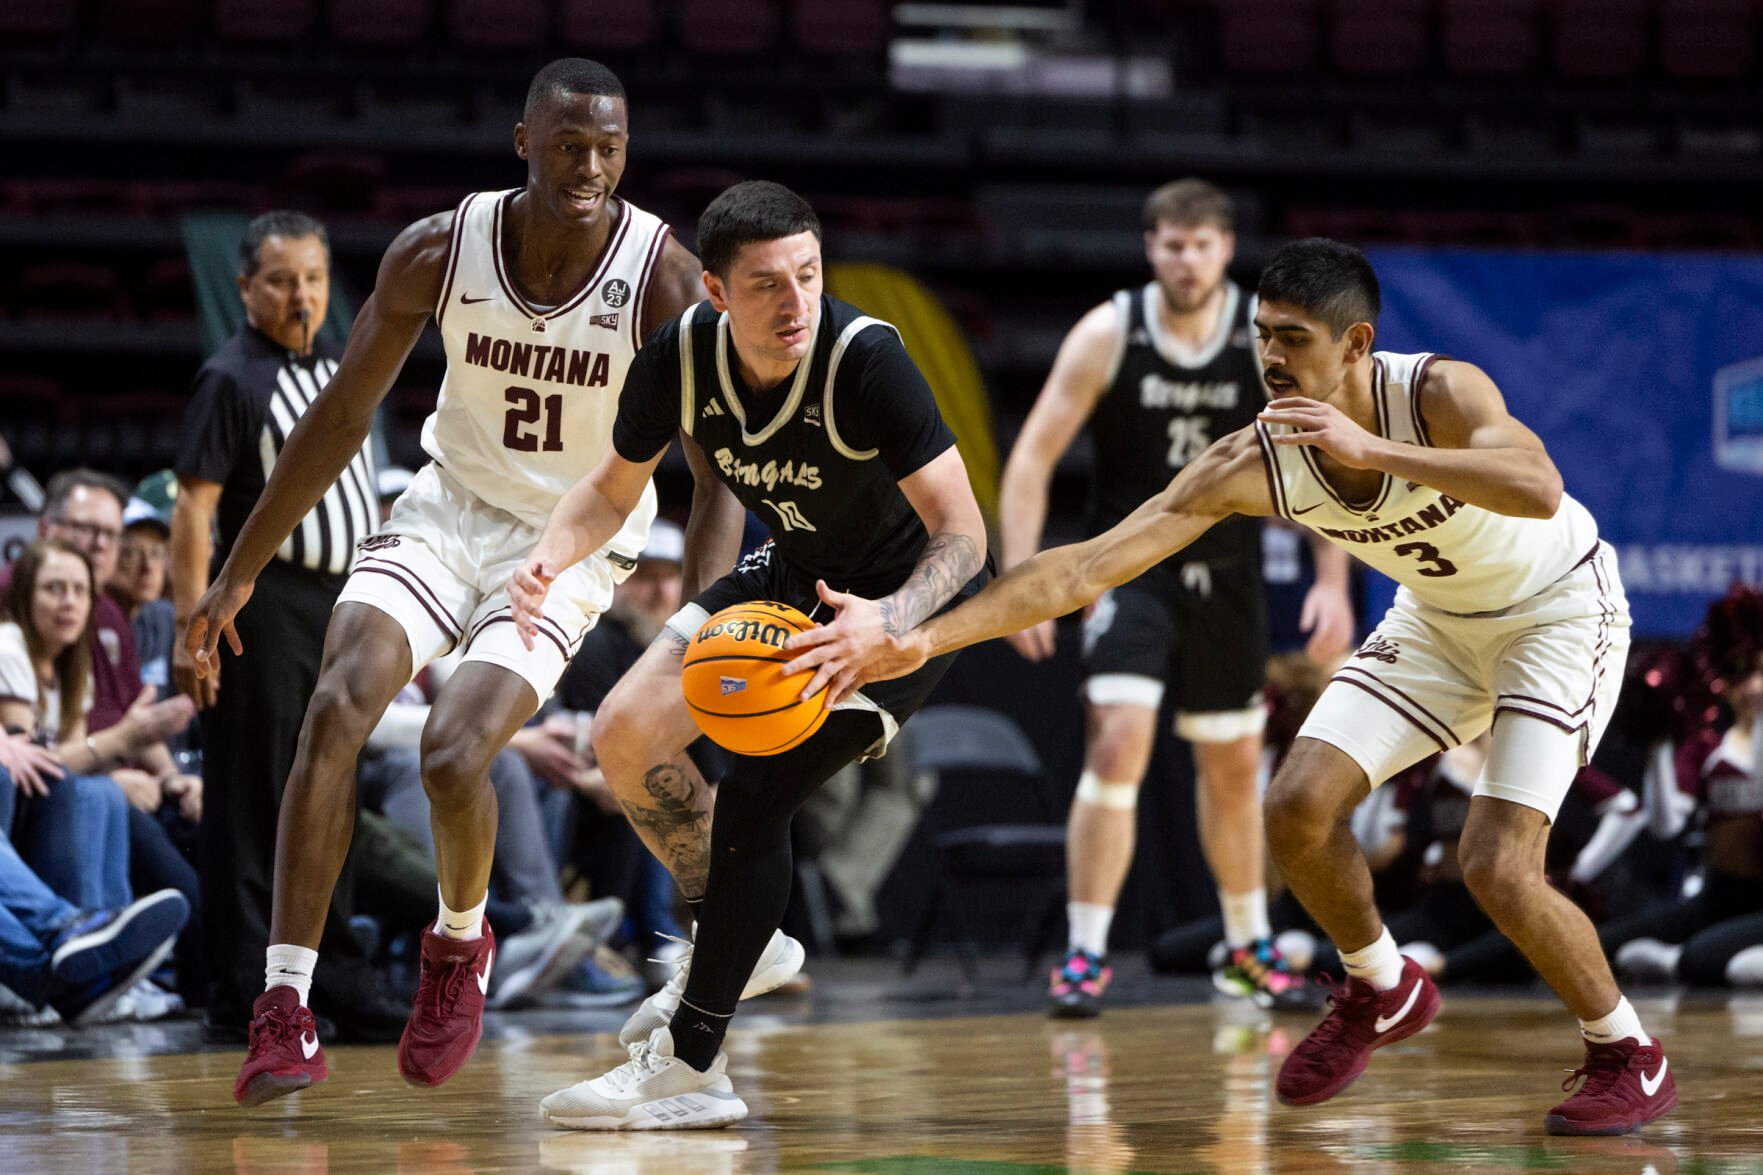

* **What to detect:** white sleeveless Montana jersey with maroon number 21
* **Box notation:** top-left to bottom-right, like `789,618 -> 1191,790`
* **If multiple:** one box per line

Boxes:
423,189 -> 670,558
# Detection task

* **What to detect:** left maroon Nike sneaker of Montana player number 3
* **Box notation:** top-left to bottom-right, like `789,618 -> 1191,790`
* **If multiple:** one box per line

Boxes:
1273,956 -> 1439,1106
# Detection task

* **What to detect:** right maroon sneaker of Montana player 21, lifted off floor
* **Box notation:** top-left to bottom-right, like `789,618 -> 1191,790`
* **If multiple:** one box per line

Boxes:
398,923 -> 495,1085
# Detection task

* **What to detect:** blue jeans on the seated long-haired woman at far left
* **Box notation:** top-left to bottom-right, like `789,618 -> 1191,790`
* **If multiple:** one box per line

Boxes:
7,775 -> 134,910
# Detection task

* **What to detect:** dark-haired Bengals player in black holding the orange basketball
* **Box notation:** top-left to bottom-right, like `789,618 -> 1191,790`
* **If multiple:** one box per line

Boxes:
510,182 -> 986,1129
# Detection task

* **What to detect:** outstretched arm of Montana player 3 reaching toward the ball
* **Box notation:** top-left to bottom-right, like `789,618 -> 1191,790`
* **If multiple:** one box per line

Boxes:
785,429 -> 1273,700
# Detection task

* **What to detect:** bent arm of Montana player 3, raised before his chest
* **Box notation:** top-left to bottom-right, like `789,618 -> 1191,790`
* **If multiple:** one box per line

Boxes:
1261,360 -> 1562,519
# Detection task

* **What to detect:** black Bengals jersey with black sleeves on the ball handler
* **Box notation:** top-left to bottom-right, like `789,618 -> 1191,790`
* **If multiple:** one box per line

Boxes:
612,296 -> 956,598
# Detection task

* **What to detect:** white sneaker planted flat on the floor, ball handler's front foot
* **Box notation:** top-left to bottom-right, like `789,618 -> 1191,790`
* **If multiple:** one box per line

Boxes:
539,1027 -> 748,1131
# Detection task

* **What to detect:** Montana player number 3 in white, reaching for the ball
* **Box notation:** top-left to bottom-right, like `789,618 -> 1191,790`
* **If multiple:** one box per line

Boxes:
785,238 -> 1677,1134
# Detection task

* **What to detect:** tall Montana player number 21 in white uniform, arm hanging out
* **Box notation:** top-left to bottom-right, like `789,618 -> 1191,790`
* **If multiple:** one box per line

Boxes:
187,58 -> 740,1106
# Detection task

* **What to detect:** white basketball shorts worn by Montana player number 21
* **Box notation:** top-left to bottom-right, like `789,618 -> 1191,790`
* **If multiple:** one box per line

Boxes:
337,462 -> 635,704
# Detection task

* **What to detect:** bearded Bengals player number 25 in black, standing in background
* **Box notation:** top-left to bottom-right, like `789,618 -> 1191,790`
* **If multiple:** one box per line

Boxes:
1000,180 -> 1352,1016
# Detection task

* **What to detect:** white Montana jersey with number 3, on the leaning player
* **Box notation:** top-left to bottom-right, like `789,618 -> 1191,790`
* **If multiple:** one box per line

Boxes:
1255,351 -> 1597,616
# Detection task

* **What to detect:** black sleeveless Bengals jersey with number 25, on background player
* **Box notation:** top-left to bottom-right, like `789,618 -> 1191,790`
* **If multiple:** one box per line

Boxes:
1090,282 -> 1266,566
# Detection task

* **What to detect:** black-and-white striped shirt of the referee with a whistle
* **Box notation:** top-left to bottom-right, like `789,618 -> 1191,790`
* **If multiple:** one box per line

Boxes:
178,326 -> 379,575
